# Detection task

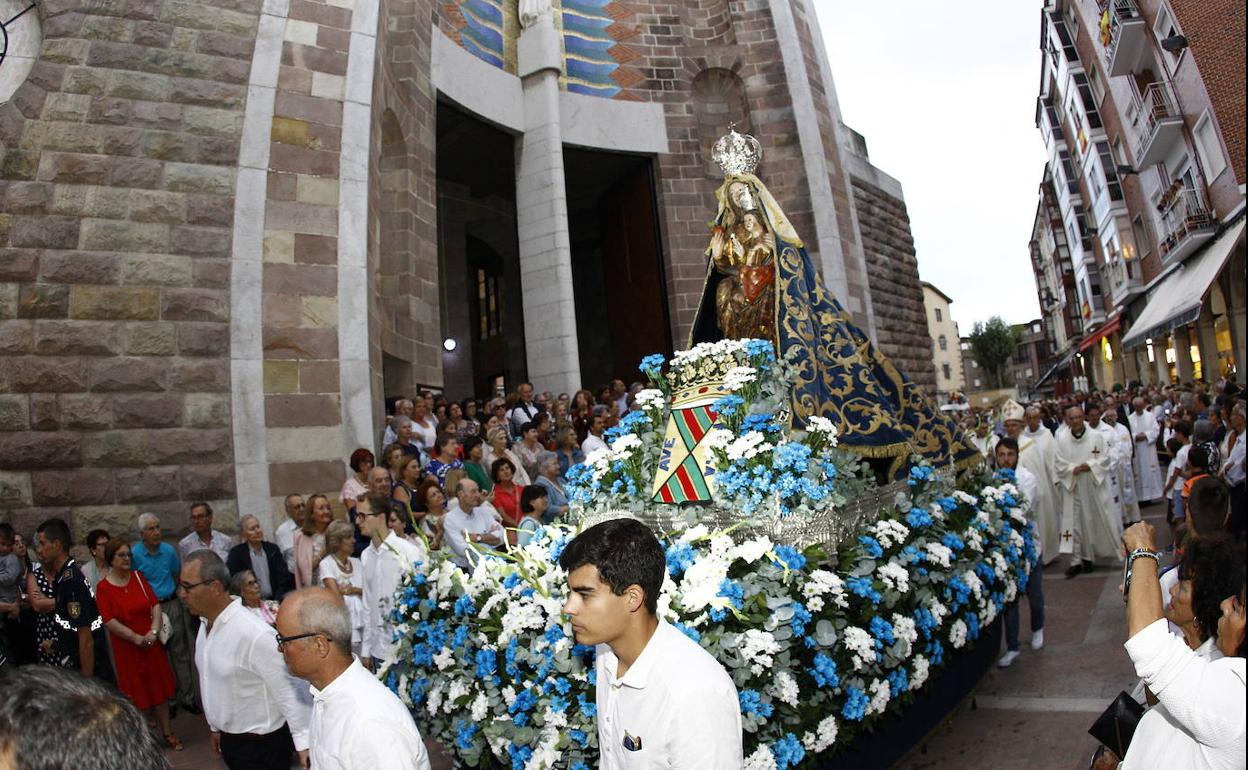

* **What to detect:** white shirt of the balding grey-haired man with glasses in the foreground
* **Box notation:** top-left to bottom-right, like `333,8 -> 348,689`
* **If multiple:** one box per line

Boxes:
311,660 -> 429,770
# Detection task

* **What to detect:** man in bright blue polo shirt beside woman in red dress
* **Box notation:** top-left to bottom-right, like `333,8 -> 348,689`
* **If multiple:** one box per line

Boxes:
130,513 -> 201,714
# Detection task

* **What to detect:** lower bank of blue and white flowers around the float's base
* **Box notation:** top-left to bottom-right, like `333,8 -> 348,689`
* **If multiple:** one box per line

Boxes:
382,464 -> 1036,770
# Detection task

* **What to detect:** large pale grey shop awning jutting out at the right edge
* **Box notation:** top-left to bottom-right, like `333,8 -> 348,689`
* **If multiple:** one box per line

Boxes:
1122,216 -> 1244,348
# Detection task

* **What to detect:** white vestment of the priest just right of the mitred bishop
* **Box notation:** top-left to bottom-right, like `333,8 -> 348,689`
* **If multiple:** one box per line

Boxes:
1053,426 -> 1122,562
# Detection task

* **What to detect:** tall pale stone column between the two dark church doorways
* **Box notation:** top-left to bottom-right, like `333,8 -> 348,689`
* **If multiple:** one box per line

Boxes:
515,14 -> 582,393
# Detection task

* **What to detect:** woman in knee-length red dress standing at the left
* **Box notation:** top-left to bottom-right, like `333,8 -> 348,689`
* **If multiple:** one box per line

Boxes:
95,538 -> 182,751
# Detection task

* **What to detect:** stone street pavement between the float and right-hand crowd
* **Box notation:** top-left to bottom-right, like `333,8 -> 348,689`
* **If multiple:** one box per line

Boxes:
896,504 -> 1169,770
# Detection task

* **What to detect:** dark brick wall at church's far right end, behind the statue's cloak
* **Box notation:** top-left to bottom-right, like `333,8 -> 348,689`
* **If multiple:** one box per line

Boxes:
854,178 -> 936,398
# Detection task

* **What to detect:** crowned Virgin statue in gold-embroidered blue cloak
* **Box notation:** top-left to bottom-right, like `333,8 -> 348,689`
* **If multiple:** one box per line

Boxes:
689,131 -> 982,478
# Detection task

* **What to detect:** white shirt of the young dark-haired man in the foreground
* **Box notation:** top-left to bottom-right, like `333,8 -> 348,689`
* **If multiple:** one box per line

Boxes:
594,620 -> 744,770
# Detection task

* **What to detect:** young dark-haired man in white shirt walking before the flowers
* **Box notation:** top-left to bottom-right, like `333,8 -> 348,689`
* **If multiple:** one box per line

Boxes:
559,519 -> 744,770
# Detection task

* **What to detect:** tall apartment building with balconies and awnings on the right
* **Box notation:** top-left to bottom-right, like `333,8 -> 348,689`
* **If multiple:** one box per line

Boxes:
1031,0 -> 1244,392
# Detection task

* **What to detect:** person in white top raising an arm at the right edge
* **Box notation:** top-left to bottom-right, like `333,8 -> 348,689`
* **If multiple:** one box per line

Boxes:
1099,522 -> 1248,770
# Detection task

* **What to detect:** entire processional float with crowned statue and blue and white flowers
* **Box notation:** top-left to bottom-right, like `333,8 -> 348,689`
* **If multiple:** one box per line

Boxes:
381,131 -> 1036,770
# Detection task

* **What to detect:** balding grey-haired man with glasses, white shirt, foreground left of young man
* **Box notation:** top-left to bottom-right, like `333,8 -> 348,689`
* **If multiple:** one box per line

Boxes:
277,588 -> 429,770
